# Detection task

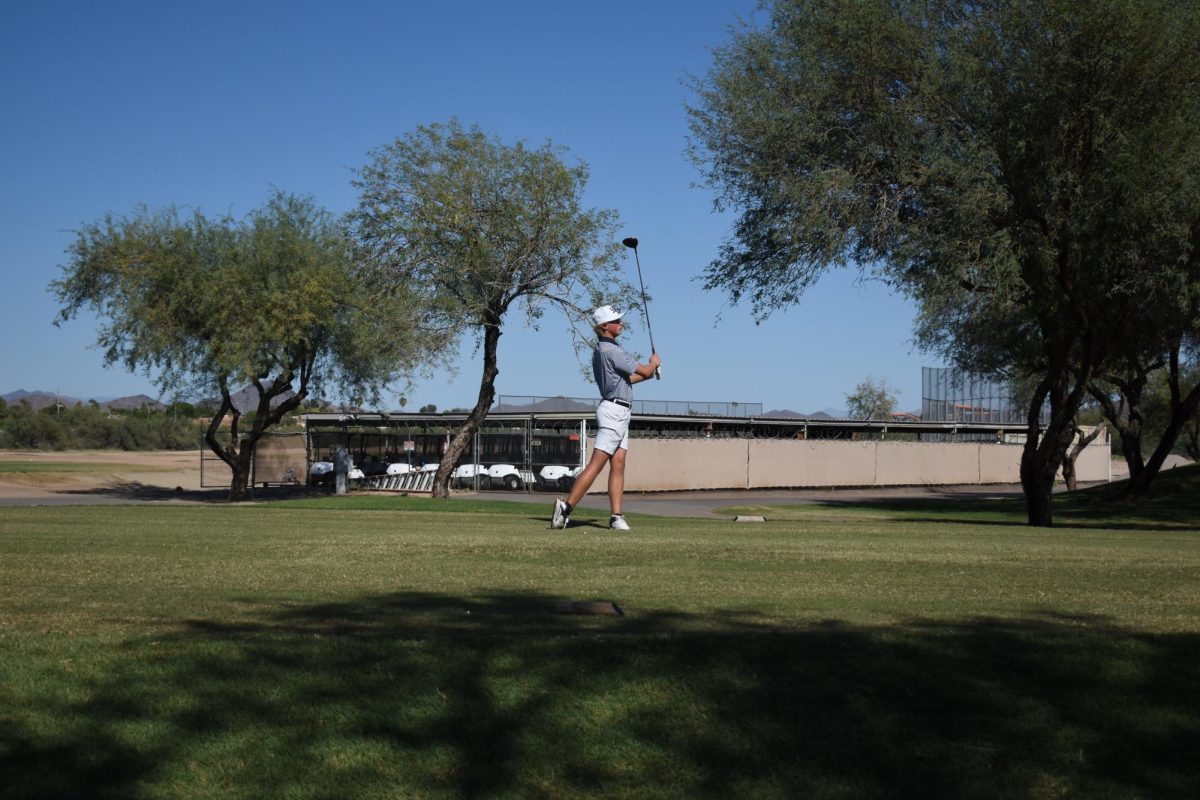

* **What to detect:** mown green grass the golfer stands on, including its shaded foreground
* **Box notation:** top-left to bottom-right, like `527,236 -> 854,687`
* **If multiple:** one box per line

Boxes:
0,497 -> 1200,800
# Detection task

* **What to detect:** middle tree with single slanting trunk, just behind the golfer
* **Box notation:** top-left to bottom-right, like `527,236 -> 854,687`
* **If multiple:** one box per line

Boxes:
352,121 -> 632,497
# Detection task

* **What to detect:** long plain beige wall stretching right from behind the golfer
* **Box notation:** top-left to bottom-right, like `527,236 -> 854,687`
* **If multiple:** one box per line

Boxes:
589,438 -> 1111,492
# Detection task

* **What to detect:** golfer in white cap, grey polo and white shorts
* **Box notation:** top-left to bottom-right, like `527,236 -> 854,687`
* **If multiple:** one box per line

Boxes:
550,306 -> 662,530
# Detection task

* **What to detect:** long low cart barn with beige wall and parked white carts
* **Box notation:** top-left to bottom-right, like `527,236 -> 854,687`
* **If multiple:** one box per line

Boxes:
270,397 -> 1111,492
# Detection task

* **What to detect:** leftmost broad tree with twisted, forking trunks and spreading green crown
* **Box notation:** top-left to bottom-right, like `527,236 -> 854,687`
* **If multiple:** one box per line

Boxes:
52,192 -> 437,500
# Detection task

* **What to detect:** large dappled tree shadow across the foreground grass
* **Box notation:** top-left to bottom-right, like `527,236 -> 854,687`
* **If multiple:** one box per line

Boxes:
0,594 -> 1200,798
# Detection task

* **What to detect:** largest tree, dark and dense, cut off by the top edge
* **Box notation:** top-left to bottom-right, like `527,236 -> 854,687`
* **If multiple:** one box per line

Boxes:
689,0 -> 1200,525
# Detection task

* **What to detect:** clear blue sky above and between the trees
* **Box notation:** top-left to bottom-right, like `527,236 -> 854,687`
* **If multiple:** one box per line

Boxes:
0,0 -> 938,411
